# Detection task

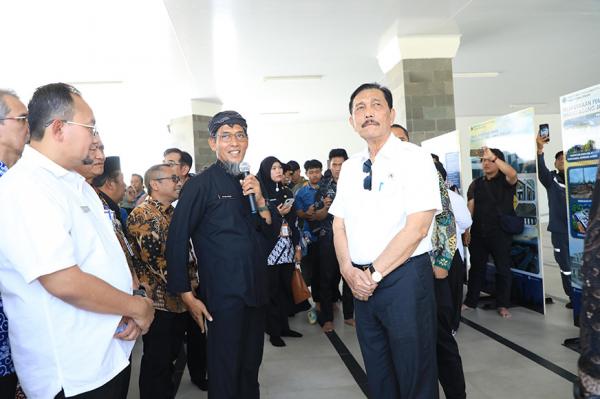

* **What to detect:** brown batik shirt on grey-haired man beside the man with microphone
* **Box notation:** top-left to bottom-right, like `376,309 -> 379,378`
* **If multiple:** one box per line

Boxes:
127,196 -> 198,313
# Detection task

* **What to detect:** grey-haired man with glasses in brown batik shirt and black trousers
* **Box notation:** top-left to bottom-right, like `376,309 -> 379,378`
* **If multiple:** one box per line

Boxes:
127,164 -> 197,399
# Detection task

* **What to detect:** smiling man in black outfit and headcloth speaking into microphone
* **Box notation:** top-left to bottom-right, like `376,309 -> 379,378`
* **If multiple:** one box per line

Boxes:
167,111 -> 278,399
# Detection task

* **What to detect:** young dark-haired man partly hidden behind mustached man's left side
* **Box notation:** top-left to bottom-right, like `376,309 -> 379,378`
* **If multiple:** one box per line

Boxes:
315,148 -> 354,332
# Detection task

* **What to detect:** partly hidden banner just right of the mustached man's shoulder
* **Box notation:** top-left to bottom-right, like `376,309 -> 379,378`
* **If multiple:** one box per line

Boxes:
421,130 -> 462,191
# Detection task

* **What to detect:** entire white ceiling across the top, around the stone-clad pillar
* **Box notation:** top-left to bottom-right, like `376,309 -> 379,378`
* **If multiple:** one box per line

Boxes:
0,0 -> 600,136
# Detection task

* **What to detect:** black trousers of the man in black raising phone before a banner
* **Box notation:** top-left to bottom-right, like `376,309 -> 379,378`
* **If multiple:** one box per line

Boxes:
465,229 -> 512,308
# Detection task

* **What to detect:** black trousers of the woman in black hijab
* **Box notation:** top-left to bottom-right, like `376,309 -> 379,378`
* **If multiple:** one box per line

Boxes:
266,263 -> 295,337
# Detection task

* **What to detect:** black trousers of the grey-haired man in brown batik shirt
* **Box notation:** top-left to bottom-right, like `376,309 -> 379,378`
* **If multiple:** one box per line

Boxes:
139,310 -> 188,399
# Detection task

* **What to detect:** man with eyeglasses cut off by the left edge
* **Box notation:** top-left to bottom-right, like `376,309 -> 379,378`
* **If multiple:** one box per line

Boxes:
0,89 -> 29,398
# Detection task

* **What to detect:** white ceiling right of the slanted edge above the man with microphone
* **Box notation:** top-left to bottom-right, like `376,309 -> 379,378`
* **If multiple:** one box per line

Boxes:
164,0 -> 600,120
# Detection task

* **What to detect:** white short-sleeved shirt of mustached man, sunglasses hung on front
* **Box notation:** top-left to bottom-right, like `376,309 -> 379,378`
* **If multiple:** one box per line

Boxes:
329,134 -> 442,264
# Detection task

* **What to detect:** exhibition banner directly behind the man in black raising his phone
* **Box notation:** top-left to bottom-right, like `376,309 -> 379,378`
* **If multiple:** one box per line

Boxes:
470,108 -> 544,313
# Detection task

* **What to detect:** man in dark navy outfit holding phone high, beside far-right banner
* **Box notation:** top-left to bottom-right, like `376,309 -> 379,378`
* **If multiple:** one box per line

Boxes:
535,131 -> 573,309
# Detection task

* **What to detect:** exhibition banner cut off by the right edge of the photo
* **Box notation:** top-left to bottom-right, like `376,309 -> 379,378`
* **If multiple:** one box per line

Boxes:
560,85 -> 600,324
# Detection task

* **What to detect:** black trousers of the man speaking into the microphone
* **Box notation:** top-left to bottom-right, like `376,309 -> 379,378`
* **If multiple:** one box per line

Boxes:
207,298 -> 266,399
